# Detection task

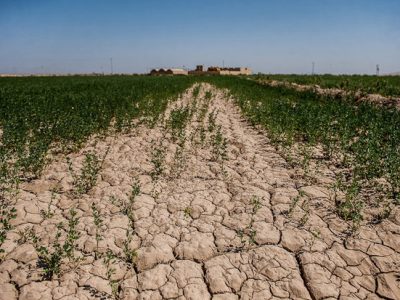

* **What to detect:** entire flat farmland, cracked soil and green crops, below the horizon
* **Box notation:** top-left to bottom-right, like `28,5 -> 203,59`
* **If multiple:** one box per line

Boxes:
0,76 -> 400,299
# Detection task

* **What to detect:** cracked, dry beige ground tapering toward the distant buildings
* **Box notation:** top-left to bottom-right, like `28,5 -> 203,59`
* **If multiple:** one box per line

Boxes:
0,84 -> 400,300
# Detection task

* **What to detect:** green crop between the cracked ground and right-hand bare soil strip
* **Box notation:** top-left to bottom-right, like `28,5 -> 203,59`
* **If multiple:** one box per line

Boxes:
207,77 -> 400,227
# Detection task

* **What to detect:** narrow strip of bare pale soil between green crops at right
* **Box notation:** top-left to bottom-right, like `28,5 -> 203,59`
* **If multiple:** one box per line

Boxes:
260,80 -> 400,109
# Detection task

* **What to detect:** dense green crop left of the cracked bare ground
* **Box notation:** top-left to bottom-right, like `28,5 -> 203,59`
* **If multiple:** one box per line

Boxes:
0,76 -> 194,177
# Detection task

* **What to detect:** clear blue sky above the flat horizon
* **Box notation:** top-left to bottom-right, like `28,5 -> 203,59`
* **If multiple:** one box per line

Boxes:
0,0 -> 400,74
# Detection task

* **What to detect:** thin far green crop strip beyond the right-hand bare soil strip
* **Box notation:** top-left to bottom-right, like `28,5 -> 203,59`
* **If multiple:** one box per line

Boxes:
254,74 -> 400,97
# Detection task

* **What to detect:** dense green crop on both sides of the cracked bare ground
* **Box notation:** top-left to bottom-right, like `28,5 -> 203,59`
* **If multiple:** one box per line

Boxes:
0,76 -> 400,206
